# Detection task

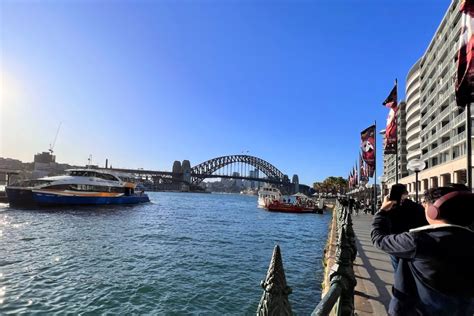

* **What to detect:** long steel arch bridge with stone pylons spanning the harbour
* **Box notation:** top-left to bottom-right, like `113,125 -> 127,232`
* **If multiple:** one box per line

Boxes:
98,155 -> 309,193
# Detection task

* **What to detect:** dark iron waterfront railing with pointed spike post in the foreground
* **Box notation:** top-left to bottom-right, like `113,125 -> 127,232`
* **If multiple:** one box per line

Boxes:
257,202 -> 357,316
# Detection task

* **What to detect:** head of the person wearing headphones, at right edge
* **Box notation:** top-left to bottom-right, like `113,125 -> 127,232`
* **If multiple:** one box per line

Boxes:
423,184 -> 474,226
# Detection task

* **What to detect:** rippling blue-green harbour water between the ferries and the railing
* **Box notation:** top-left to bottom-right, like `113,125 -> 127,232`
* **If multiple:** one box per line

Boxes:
0,193 -> 331,315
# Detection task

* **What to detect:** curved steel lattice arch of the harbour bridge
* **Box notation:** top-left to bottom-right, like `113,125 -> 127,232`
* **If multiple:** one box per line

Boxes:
191,155 -> 285,184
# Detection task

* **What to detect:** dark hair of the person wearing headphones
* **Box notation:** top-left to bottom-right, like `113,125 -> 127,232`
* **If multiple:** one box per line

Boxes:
424,183 -> 474,226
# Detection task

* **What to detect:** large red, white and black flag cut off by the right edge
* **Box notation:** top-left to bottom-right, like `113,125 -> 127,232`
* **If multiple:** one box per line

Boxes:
456,0 -> 474,107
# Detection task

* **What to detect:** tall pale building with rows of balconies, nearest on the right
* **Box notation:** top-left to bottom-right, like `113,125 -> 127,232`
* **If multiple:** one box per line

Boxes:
399,0 -> 472,194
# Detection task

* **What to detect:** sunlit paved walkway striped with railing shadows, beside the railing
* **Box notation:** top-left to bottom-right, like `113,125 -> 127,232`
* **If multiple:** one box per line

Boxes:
352,213 -> 393,316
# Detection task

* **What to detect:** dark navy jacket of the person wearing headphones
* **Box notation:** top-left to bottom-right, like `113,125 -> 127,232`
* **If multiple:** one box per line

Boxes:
371,211 -> 474,316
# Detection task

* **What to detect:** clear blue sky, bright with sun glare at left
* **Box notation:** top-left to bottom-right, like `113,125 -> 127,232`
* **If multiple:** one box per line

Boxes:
0,0 -> 451,184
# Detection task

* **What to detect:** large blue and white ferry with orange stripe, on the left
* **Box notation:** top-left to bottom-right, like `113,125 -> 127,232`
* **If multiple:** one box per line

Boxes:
5,169 -> 150,207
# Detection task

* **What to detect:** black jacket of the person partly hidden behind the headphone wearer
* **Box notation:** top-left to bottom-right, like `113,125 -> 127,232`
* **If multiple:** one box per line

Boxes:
388,199 -> 428,234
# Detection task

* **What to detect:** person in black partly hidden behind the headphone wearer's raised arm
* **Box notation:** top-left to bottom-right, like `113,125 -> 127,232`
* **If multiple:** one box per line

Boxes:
381,184 -> 428,271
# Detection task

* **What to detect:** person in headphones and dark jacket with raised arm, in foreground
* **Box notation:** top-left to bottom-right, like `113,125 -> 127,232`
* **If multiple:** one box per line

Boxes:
371,186 -> 474,316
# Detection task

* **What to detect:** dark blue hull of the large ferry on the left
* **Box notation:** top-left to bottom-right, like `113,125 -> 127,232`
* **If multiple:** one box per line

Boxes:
7,188 -> 150,207
